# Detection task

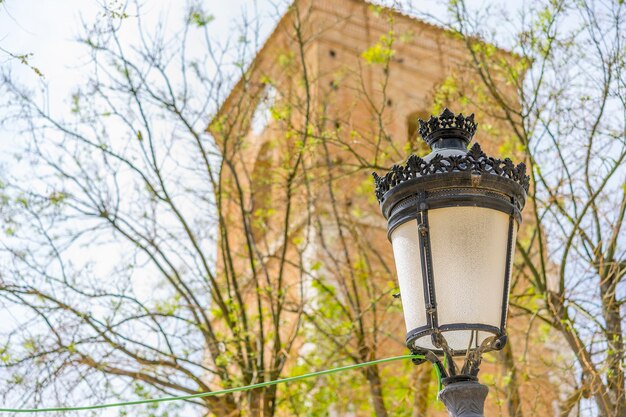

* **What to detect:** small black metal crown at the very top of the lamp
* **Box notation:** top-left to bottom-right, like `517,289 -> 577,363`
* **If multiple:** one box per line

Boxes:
419,108 -> 478,146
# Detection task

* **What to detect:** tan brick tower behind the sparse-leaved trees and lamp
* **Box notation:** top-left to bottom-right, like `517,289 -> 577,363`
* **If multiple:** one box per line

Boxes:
209,0 -> 559,417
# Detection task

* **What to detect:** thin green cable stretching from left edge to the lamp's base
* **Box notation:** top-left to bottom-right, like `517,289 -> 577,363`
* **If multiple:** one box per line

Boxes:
0,355 -> 441,413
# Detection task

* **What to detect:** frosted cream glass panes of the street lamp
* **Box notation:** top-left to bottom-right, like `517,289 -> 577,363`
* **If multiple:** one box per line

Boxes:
391,207 -> 517,352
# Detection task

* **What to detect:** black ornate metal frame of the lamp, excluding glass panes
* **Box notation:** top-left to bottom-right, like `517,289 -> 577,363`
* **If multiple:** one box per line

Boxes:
373,109 -> 529,383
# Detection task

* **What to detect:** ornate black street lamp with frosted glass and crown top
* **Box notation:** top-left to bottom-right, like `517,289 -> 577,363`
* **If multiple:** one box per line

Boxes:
373,109 -> 529,417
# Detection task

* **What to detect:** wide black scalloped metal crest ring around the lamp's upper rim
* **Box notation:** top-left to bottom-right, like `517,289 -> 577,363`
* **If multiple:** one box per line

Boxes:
372,142 -> 530,202
